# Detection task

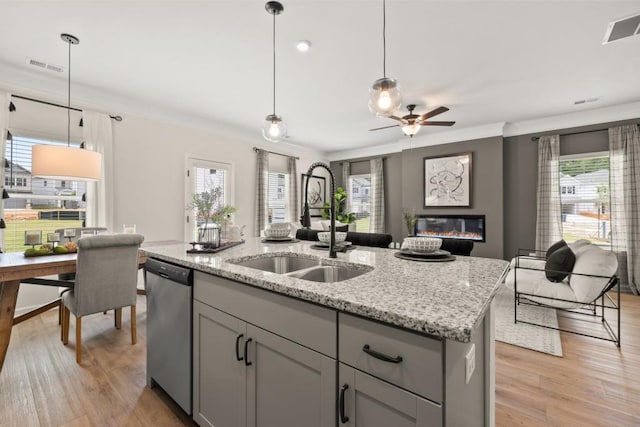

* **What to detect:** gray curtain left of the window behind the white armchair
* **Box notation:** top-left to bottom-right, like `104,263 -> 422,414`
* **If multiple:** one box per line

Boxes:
536,135 -> 562,251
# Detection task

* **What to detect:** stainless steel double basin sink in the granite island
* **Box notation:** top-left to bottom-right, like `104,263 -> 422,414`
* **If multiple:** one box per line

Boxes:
229,254 -> 373,283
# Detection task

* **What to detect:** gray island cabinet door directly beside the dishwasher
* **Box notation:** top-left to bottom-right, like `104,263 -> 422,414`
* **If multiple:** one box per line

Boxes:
192,301 -> 246,427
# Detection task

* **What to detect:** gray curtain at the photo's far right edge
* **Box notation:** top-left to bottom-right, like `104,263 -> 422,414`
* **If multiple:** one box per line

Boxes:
609,125 -> 640,295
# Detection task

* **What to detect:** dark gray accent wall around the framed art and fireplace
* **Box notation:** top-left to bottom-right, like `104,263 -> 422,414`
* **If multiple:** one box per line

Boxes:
331,136 -> 504,258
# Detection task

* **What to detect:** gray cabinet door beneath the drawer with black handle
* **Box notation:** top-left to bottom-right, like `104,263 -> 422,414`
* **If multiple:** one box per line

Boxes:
338,363 -> 442,427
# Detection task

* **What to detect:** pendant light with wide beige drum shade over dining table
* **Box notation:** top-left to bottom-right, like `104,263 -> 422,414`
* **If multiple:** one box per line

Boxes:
31,34 -> 102,181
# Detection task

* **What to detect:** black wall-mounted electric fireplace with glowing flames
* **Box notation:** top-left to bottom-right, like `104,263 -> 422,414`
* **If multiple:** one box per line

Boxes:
415,215 -> 486,242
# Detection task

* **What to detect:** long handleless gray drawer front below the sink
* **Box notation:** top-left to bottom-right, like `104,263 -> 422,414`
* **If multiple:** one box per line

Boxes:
194,271 -> 337,359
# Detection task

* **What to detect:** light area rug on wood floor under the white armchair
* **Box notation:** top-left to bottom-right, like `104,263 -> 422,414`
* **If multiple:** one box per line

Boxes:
494,286 -> 562,357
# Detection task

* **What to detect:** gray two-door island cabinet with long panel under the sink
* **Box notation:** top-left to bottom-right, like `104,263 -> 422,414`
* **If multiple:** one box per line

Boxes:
193,275 -> 337,427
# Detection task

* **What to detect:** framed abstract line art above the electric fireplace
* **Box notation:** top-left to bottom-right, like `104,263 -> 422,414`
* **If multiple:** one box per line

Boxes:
424,153 -> 473,208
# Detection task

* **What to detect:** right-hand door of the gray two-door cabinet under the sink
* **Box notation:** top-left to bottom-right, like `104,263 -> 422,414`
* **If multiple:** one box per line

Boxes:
247,325 -> 336,427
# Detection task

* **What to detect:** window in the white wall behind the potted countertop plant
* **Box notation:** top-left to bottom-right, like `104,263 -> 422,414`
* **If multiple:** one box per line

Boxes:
185,158 -> 234,242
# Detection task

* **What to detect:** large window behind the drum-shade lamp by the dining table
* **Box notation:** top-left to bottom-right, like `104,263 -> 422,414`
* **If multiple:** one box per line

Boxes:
4,134 -> 86,252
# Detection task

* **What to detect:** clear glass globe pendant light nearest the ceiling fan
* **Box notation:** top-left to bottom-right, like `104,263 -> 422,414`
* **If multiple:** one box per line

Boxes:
369,0 -> 402,117
